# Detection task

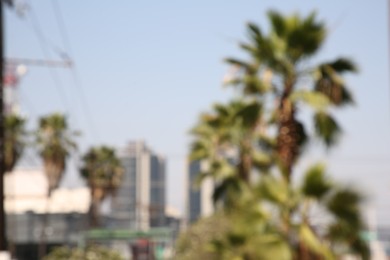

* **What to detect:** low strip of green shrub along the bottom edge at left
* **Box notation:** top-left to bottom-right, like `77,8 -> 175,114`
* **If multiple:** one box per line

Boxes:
43,246 -> 124,260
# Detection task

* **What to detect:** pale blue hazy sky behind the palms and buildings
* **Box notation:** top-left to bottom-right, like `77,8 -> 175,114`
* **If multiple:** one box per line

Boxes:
5,0 -> 390,225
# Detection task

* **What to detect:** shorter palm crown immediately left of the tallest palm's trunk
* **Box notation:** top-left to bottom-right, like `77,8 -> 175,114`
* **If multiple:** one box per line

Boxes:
190,99 -> 272,206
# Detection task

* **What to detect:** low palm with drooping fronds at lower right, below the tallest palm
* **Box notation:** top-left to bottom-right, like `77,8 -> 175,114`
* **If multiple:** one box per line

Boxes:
255,164 -> 370,260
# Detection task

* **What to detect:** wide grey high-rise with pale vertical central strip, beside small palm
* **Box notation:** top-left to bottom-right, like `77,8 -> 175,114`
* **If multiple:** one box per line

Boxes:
109,141 -> 166,230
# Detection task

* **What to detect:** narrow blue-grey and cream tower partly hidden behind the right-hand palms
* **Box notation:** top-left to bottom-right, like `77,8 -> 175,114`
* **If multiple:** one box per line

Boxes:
186,161 -> 214,224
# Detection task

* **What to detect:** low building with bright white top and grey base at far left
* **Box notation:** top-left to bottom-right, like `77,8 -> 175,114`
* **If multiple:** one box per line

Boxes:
5,169 -> 90,260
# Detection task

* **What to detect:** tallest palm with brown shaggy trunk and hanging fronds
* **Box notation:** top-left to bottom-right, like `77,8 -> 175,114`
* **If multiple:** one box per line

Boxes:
226,11 -> 356,181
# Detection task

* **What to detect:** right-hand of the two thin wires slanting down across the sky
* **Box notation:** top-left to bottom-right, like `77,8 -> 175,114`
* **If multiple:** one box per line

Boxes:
51,0 -> 100,141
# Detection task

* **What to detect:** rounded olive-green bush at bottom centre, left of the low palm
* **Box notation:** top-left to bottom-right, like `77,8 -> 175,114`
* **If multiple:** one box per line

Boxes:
175,211 -> 292,260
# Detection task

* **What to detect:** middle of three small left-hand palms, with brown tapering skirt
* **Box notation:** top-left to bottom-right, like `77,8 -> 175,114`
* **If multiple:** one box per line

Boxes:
36,113 -> 78,197
